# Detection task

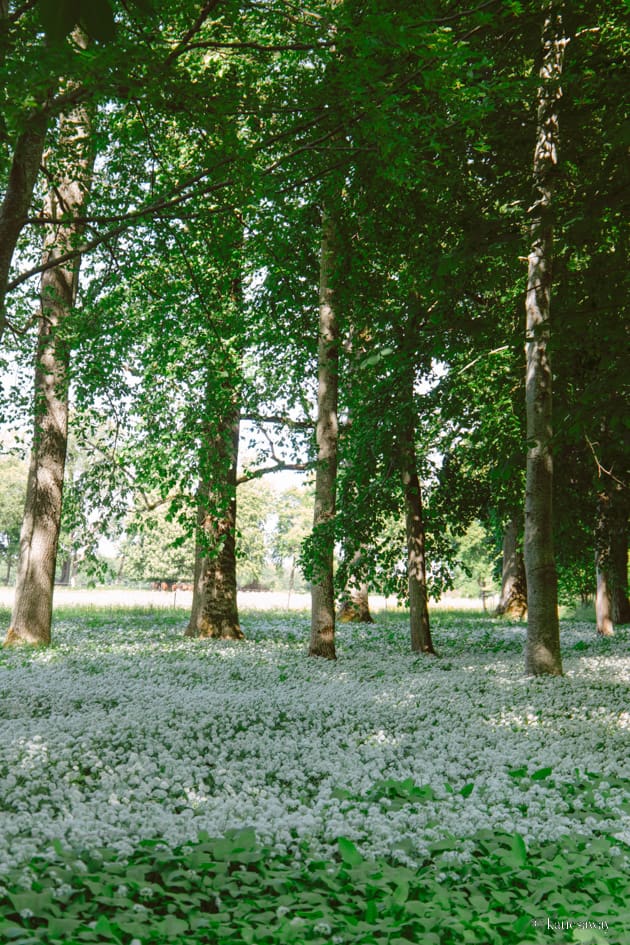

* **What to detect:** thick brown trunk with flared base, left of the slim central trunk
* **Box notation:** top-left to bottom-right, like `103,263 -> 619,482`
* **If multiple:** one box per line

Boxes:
186,401 -> 243,640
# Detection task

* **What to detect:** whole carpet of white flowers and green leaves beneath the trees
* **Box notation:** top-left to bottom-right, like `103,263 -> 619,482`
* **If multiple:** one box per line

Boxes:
0,610 -> 630,945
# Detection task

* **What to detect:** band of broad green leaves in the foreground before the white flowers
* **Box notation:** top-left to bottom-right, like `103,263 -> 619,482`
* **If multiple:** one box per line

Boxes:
0,828 -> 630,945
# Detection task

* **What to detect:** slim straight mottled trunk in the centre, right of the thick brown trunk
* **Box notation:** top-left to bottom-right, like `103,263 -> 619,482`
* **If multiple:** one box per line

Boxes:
309,214 -> 339,659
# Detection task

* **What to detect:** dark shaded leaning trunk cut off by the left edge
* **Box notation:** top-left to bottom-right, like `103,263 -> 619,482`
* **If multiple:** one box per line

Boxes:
0,115 -> 47,341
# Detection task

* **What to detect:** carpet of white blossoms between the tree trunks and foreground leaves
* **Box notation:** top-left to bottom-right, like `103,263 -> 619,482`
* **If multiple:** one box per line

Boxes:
0,615 -> 630,874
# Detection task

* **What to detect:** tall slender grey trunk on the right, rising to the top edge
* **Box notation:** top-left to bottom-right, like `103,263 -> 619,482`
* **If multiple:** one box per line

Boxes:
525,4 -> 565,676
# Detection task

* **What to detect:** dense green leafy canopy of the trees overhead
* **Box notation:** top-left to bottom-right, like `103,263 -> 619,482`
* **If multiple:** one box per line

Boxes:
0,0 -> 629,664
